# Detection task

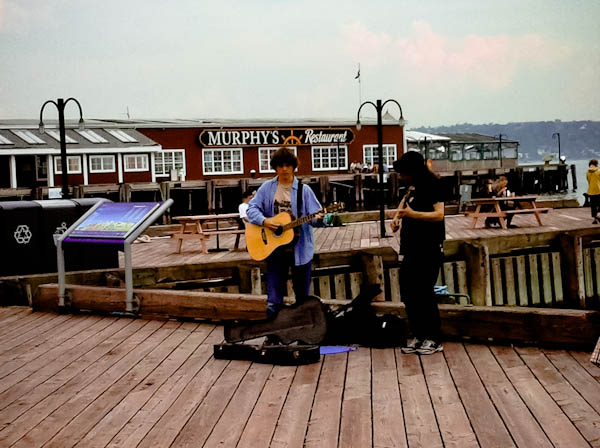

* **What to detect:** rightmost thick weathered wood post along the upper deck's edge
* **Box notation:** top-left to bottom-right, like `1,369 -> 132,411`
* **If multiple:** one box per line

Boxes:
558,233 -> 586,308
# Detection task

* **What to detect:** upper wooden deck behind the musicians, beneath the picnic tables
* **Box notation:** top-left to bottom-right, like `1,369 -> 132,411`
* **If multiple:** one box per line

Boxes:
127,208 -> 600,268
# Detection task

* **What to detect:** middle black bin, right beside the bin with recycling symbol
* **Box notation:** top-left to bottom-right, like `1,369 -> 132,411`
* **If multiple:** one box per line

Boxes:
33,199 -> 81,272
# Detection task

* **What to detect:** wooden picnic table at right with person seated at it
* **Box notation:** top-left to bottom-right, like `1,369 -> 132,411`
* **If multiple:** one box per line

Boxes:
467,195 -> 550,229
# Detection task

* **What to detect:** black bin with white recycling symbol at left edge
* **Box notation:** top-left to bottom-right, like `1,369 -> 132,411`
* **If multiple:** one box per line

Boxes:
0,201 -> 43,276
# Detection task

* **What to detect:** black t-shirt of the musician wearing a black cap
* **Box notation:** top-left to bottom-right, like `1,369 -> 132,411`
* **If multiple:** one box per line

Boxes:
400,175 -> 446,254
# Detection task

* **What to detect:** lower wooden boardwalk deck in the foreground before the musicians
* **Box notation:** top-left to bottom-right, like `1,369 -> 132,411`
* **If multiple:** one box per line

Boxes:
0,308 -> 600,448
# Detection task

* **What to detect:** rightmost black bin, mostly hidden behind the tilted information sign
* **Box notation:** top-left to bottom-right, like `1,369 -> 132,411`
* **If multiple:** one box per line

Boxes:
64,198 -> 121,271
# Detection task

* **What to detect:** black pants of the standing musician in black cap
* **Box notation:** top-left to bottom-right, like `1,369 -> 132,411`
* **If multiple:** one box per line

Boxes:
400,246 -> 442,342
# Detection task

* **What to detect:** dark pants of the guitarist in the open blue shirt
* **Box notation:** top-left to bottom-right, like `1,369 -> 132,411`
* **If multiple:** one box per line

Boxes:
267,247 -> 312,311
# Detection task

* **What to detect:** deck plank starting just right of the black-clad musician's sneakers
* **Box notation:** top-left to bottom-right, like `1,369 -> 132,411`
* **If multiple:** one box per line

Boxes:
444,342 -> 515,448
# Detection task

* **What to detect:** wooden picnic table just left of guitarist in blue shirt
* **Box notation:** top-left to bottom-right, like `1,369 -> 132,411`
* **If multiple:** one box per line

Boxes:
171,213 -> 244,254
